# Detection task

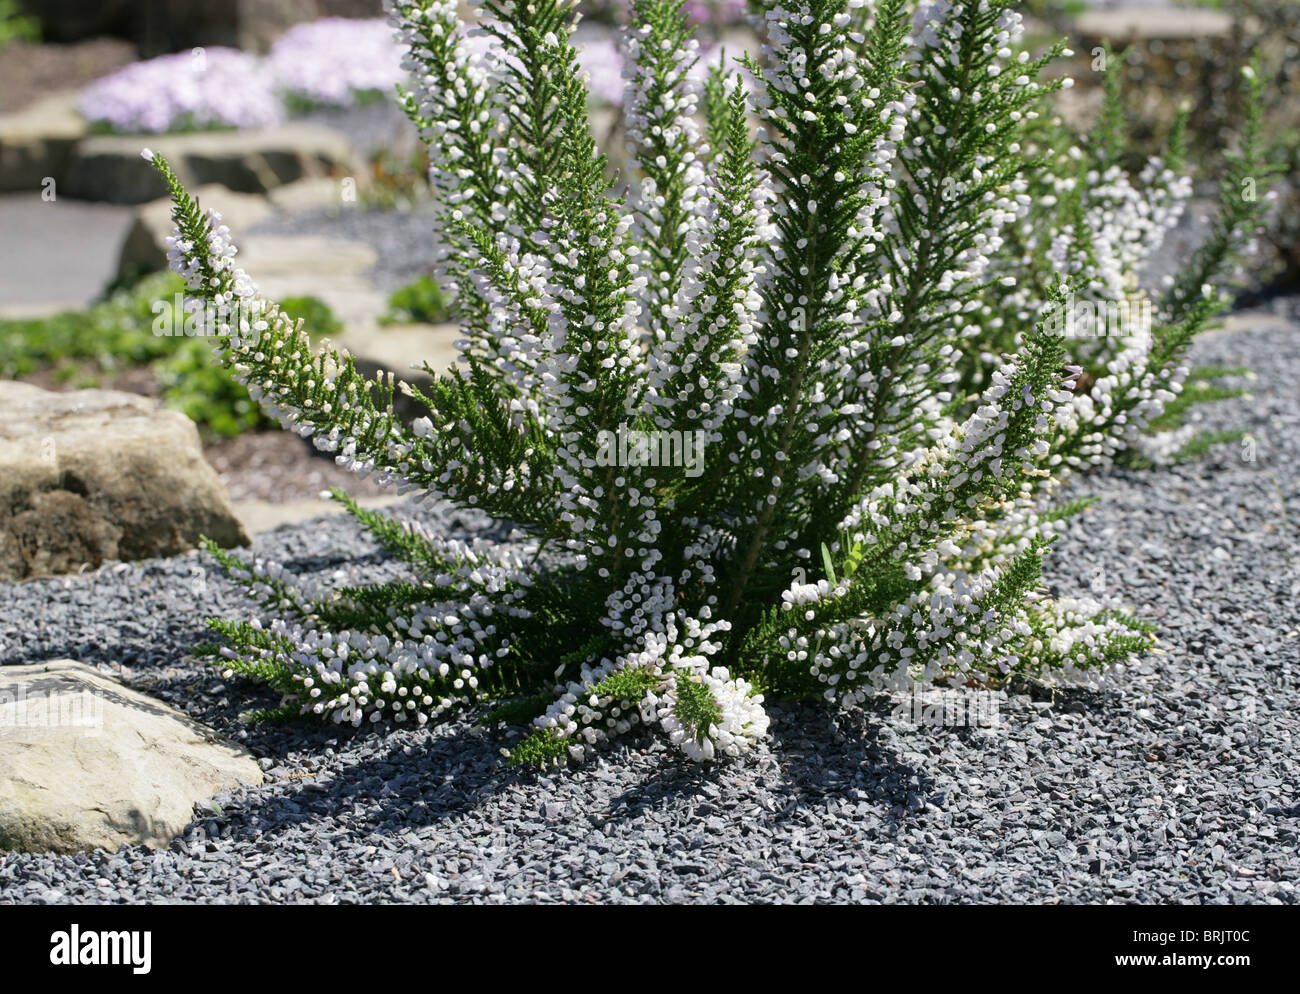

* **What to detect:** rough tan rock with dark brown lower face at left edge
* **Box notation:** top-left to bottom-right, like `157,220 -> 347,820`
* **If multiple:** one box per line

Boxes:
0,382 -> 248,580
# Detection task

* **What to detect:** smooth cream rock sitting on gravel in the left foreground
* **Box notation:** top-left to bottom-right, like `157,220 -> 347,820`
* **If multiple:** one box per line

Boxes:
0,660 -> 263,852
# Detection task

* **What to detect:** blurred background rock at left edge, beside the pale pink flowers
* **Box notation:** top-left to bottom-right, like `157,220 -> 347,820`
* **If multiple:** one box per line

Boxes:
0,92 -> 87,196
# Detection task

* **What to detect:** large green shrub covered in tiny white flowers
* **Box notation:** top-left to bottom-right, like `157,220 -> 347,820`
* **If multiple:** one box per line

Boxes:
147,0 -> 1251,761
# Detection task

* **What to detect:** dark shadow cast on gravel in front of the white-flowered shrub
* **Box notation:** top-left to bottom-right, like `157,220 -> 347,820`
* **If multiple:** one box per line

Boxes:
189,706 -> 933,845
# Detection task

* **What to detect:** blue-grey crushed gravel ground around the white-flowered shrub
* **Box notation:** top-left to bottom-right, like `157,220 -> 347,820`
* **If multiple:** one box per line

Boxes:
0,312 -> 1300,903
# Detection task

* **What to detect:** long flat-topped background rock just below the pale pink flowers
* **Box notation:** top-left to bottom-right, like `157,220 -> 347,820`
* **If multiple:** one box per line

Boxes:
62,122 -> 356,204
